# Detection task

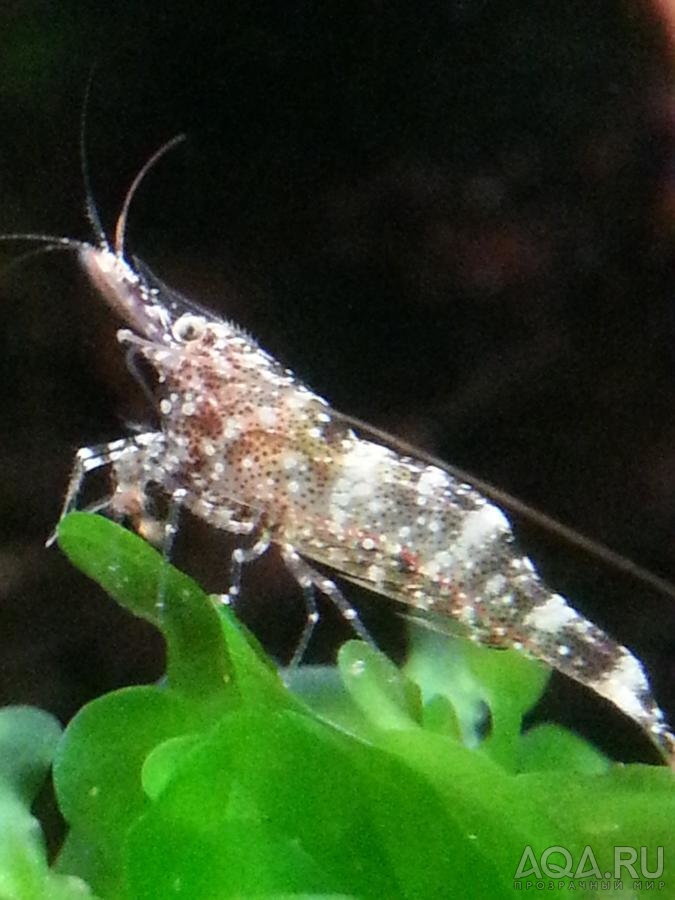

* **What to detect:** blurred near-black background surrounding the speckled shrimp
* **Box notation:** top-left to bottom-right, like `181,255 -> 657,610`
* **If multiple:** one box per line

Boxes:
0,0 -> 675,759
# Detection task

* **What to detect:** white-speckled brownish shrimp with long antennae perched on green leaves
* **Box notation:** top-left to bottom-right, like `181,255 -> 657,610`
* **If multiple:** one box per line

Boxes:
3,137 -> 675,766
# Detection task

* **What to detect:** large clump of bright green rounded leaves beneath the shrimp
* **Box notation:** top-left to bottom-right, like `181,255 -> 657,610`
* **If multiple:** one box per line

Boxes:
42,514 -> 675,900
